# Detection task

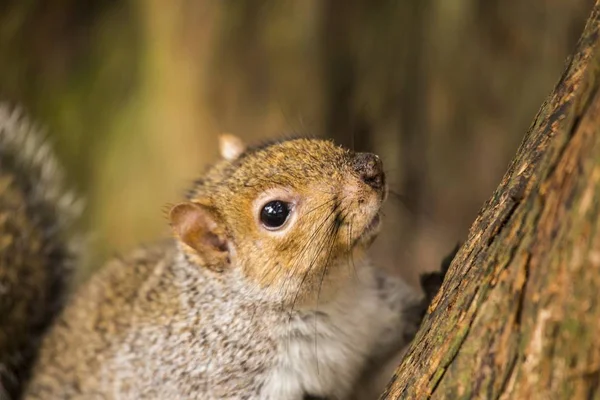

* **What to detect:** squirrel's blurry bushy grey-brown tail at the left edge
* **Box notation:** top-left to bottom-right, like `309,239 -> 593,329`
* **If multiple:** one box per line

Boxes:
0,104 -> 81,400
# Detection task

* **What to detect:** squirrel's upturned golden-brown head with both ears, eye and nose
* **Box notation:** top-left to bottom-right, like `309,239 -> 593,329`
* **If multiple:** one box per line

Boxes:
170,135 -> 387,304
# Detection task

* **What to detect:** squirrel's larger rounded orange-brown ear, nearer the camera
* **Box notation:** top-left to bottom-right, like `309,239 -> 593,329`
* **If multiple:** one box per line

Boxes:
169,202 -> 229,270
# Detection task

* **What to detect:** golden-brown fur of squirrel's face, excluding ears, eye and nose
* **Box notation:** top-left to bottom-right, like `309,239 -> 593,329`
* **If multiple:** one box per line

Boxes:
185,139 -> 385,301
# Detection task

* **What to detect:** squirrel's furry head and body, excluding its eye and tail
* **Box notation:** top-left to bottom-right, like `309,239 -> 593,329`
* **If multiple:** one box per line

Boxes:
26,135 -> 421,400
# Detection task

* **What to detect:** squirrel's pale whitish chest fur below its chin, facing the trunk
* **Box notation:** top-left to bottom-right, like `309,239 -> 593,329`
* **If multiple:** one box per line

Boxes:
263,268 -> 417,400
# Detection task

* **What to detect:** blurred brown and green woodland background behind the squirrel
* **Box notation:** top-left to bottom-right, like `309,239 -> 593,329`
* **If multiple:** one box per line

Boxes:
0,0 -> 593,283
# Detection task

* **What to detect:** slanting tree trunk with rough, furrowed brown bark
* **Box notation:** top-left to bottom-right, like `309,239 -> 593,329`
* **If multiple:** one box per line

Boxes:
381,0 -> 600,399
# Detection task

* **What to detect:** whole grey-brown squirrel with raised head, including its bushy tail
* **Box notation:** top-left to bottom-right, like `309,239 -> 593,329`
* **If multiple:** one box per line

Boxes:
0,104 -> 450,400
